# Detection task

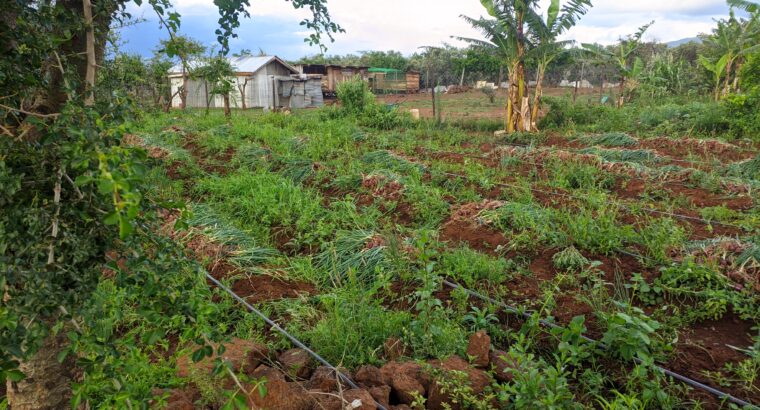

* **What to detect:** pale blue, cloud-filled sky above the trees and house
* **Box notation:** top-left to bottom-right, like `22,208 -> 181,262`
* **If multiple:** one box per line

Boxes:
120,0 -> 728,60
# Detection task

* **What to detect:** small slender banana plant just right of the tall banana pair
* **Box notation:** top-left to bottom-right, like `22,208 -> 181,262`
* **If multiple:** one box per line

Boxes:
582,21 -> 654,107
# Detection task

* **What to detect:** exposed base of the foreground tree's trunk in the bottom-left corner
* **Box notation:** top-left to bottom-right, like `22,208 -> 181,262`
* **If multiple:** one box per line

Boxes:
6,332 -> 73,410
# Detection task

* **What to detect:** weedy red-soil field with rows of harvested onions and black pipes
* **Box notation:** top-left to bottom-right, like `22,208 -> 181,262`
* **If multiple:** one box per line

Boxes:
117,94 -> 760,409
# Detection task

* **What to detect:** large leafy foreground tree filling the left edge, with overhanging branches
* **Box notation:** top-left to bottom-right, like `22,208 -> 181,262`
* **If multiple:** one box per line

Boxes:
0,0 -> 342,409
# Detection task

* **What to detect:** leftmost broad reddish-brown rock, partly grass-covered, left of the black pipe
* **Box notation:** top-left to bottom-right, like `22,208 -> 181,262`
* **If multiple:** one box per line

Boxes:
177,339 -> 269,377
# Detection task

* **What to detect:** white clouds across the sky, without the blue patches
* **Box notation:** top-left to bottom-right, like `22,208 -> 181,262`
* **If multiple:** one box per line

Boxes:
127,0 -> 728,53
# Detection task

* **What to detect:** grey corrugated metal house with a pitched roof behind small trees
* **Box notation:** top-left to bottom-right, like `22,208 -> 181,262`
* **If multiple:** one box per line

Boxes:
169,56 -> 323,109
